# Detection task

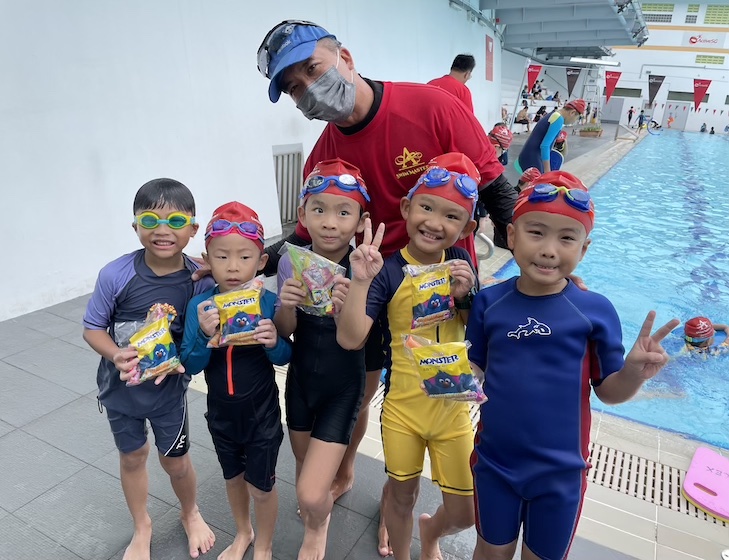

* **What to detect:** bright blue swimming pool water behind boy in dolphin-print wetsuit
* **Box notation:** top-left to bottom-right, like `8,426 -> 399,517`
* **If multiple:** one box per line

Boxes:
496,131 -> 729,449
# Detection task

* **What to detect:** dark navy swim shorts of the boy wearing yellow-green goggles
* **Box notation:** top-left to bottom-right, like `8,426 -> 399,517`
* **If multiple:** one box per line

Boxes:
106,394 -> 190,457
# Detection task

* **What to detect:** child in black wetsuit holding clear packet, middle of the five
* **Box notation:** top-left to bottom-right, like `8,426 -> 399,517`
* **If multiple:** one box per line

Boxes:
275,159 -> 369,558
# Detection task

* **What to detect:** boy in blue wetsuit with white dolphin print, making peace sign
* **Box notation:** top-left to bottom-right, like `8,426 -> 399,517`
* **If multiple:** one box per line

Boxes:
466,171 -> 678,560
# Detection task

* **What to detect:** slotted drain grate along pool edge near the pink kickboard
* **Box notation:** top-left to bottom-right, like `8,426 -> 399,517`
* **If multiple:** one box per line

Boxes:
371,385 -> 729,527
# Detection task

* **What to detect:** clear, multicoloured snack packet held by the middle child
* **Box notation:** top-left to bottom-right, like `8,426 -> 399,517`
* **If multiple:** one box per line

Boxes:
280,243 -> 347,317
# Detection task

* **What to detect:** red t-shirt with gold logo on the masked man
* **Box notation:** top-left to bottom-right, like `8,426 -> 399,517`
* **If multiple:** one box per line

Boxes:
296,82 -> 504,264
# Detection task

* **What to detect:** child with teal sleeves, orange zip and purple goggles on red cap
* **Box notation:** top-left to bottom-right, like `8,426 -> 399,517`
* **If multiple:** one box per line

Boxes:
180,202 -> 291,560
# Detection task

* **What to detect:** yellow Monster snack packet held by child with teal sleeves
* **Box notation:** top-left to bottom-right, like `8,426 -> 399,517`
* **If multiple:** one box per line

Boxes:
208,276 -> 263,348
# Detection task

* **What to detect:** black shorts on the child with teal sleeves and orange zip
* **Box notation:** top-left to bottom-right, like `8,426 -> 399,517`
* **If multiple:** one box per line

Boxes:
205,392 -> 283,492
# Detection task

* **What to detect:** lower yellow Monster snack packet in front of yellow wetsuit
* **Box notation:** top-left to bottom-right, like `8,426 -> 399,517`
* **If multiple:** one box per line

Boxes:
403,335 -> 486,403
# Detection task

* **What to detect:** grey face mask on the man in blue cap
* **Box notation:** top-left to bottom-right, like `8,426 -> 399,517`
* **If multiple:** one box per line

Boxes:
296,54 -> 355,122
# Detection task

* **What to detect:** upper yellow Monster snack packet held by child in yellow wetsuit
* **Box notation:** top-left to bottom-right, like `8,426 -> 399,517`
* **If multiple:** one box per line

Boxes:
403,262 -> 456,330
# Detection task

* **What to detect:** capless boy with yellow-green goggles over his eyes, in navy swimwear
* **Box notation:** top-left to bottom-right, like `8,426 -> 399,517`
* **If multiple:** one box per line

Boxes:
83,179 -> 215,559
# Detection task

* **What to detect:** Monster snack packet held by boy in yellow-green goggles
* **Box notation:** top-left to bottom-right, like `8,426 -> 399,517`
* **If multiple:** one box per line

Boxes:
127,303 -> 180,386
